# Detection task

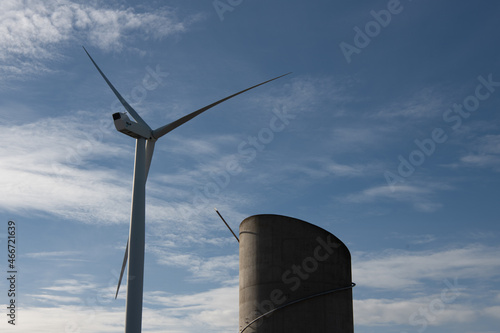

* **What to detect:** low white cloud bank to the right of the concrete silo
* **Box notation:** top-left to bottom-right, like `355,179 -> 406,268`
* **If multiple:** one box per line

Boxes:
353,245 -> 500,331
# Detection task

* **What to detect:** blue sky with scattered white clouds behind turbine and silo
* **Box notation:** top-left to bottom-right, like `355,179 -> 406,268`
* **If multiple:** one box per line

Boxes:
0,0 -> 500,333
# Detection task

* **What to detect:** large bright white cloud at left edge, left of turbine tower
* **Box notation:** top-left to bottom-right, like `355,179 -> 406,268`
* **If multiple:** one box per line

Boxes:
0,113 -> 134,223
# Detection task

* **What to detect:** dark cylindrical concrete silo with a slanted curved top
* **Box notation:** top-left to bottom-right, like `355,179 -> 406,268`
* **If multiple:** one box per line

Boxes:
239,215 -> 354,333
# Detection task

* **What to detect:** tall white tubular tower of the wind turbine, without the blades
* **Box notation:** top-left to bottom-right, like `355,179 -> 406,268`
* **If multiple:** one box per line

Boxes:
125,138 -> 146,333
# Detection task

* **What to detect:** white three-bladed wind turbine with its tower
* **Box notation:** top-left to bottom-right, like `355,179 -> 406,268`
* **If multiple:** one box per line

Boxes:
83,47 -> 290,333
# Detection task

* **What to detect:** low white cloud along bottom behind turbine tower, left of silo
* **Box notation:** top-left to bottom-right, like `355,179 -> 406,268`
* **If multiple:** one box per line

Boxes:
17,286 -> 238,333
